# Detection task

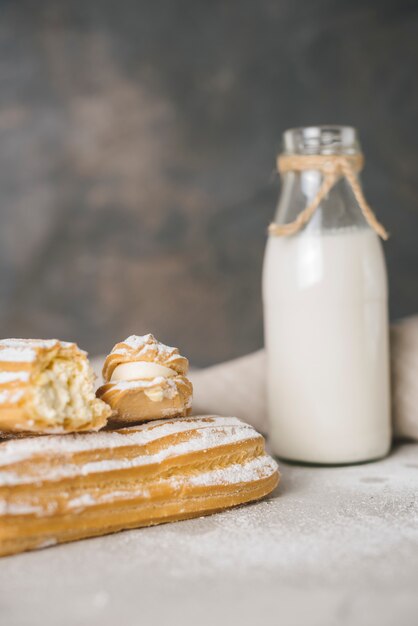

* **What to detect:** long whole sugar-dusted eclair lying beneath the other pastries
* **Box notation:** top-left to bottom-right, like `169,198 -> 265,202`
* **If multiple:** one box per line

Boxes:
0,416 -> 279,555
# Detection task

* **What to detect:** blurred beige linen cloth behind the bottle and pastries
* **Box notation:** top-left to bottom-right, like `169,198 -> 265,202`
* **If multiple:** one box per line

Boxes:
93,315 -> 418,440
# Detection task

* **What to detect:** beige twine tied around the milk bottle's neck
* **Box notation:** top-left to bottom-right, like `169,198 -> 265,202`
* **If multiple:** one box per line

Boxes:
269,154 -> 389,240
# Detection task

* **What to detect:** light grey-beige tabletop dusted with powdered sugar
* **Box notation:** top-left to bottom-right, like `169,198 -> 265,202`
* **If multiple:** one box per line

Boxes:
0,444 -> 418,626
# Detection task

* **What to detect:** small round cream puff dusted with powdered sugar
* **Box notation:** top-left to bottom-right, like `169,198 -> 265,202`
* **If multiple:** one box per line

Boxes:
97,335 -> 193,423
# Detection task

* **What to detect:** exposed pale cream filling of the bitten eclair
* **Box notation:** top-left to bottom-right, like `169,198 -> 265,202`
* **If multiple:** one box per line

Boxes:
34,359 -> 102,426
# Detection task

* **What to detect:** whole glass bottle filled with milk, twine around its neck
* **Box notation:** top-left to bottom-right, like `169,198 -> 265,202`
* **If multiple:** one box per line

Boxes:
263,126 -> 391,464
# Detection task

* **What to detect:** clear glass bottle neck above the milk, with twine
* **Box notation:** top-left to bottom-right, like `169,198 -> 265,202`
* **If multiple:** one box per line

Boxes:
269,126 -> 389,239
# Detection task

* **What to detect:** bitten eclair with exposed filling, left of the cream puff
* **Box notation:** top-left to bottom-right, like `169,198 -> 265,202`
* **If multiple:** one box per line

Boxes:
0,339 -> 112,433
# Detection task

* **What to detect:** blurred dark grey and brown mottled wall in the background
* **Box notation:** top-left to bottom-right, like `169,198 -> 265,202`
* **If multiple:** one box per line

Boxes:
0,0 -> 418,365
